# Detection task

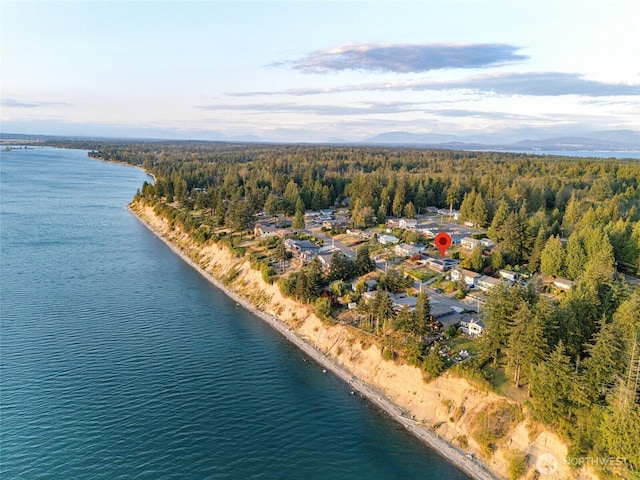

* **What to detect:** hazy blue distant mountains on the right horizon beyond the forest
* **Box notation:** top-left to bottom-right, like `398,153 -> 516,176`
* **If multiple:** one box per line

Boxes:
360,130 -> 640,151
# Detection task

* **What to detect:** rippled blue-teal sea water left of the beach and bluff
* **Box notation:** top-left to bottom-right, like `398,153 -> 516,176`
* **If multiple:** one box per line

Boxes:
0,149 -> 468,480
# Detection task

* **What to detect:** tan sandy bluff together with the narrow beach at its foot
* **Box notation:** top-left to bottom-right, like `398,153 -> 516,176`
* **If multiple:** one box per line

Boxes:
130,201 -> 597,480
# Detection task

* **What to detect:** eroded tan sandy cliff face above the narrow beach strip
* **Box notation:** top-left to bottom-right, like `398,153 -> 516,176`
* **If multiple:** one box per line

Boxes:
131,202 -> 598,480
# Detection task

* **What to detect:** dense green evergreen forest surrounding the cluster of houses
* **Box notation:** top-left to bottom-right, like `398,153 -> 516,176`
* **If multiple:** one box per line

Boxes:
56,142 -> 640,478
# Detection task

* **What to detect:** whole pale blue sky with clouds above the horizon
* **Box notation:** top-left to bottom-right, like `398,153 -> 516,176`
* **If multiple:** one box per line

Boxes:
0,0 -> 640,142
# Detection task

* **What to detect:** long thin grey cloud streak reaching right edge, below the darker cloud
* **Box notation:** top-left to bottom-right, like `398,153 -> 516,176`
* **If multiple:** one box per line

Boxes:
230,72 -> 640,97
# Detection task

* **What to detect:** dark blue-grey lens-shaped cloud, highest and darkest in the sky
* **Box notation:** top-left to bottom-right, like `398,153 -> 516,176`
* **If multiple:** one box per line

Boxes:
272,43 -> 528,73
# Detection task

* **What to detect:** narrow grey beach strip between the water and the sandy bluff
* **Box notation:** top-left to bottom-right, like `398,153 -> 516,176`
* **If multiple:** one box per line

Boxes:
128,206 -> 500,480
